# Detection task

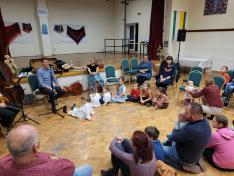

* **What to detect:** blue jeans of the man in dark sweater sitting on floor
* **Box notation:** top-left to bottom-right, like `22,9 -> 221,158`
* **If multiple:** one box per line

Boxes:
163,142 -> 193,170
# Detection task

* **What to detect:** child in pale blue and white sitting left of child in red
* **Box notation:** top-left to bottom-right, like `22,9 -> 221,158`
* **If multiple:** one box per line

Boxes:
112,77 -> 127,103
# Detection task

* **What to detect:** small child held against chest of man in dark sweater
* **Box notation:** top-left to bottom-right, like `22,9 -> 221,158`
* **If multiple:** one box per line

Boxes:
163,108 -> 189,146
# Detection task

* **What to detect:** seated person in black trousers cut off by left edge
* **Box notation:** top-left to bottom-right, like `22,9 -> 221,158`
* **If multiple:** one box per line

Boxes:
0,93 -> 20,128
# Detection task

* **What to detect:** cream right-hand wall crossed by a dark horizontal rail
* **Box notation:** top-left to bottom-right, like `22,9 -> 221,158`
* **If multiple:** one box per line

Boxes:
173,0 -> 234,70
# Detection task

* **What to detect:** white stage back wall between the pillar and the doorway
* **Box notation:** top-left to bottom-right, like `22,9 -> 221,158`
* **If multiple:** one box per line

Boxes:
47,0 -> 114,54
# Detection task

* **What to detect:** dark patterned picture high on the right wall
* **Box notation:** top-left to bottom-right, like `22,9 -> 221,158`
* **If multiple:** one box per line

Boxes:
204,0 -> 228,15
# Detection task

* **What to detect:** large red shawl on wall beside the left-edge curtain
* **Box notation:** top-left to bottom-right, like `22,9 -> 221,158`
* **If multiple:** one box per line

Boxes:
6,23 -> 21,44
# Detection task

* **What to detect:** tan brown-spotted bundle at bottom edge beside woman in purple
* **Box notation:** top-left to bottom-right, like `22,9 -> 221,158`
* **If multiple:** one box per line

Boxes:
155,160 -> 177,176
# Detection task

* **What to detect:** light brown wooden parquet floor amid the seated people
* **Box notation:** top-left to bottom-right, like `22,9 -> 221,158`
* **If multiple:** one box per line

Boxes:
0,79 -> 234,176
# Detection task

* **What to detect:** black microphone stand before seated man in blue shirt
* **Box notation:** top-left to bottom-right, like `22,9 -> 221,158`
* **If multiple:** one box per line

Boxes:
39,65 -> 64,118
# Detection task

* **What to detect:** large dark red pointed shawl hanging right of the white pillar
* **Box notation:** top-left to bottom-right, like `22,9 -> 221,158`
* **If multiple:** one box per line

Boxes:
67,26 -> 85,45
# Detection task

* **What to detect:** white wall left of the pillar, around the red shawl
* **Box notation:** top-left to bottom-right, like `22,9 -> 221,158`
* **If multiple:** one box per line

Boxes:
0,0 -> 41,57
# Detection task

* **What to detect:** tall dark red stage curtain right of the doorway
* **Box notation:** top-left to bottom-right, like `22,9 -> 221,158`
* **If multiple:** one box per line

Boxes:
148,0 -> 165,60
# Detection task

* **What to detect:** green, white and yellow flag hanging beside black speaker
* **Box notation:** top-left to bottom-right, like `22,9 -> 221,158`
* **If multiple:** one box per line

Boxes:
172,11 -> 187,41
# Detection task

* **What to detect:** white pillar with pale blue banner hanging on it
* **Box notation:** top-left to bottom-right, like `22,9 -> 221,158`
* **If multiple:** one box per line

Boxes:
37,0 -> 52,56
